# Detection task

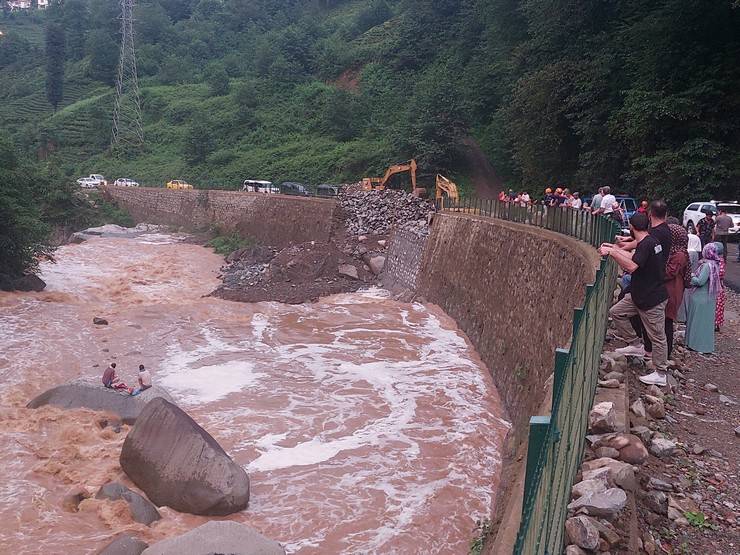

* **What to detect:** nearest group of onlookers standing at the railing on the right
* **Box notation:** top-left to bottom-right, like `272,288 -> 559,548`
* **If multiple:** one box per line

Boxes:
599,199 -> 732,386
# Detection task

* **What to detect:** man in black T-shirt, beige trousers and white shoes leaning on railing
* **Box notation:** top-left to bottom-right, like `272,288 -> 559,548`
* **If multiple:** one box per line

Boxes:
599,213 -> 668,386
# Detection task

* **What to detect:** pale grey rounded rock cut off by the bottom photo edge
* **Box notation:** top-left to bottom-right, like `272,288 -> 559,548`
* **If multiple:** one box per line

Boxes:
143,520 -> 285,555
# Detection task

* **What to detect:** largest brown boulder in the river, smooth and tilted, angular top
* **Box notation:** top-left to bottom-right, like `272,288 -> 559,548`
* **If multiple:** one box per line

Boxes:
120,398 -> 249,515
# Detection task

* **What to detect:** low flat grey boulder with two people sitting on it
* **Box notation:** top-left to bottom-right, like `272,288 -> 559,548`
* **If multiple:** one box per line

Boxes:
28,380 -> 172,424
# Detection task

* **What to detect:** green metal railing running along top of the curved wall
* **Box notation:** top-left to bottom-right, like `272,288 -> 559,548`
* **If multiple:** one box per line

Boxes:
439,199 -> 620,555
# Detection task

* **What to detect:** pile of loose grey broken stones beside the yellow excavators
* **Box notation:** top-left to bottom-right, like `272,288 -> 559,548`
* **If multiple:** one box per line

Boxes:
339,190 -> 434,236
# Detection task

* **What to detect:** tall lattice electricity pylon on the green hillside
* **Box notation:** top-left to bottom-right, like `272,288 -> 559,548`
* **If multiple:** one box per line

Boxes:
111,0 -> 144,152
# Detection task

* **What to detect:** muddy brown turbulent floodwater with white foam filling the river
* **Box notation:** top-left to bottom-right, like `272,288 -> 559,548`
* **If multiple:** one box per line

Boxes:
0,234 -> 508,554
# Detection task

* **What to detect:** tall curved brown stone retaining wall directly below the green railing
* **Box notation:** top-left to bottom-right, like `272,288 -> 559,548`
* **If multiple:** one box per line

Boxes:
417,214 -> 598,443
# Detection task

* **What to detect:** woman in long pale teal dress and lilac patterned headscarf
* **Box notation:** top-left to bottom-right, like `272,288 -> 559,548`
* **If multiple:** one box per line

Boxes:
686,243 -> 722,353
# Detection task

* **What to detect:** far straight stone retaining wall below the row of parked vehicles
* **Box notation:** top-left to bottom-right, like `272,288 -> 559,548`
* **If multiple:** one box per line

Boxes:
105,187 -> 336,247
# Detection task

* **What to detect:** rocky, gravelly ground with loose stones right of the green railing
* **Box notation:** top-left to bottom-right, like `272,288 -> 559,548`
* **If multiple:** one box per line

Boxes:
566,291 -> 740,555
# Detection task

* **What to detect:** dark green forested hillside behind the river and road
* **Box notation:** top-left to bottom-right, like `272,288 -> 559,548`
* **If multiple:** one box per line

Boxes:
0,0 -> 740,204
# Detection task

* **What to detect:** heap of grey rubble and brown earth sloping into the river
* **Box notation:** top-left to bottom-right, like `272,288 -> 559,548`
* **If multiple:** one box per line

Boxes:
212,190 -> 434,304
